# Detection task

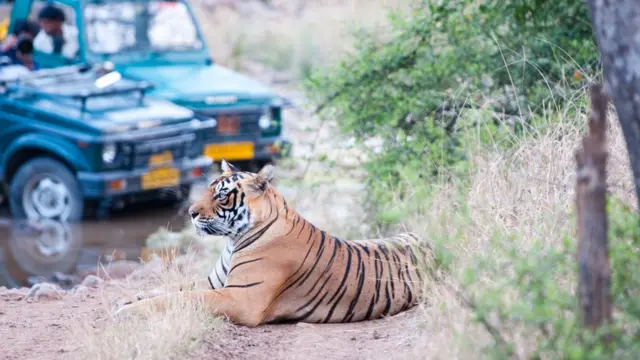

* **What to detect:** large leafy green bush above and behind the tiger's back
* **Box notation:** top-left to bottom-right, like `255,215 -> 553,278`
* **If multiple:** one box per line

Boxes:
306,0 -> 597,208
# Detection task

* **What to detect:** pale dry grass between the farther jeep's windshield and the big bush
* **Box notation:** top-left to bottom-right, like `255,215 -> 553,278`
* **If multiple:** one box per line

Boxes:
193,0 -> 410,79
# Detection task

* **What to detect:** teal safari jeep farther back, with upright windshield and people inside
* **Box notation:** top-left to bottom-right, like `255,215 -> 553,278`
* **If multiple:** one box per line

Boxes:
10,0 -> 291,169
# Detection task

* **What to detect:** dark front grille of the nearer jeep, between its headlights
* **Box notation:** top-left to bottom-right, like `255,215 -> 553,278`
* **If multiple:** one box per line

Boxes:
127,134 -> 195,168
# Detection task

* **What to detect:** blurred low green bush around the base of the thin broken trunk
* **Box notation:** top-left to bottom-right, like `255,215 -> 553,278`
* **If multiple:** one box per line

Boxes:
463,199 -> 640,359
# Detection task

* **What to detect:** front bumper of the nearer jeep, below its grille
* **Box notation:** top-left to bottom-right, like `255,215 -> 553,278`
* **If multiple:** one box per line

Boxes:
77,156 -> 213,199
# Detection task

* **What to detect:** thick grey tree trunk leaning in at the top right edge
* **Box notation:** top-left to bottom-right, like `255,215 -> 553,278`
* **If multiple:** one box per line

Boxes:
587,0 -> 640,208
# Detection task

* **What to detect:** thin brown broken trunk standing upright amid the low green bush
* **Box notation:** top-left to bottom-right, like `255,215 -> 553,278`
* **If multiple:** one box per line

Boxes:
576,85 -> 611,329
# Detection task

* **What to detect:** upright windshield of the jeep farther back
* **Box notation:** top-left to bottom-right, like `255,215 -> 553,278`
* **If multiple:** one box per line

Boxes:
83,0 -> 204,55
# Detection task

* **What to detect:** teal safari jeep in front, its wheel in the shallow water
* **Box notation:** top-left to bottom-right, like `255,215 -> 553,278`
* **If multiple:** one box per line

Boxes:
0,65 -> 215,221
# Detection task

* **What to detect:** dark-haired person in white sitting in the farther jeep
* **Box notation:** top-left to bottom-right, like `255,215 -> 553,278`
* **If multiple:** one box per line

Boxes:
33,4 -> 79,59
